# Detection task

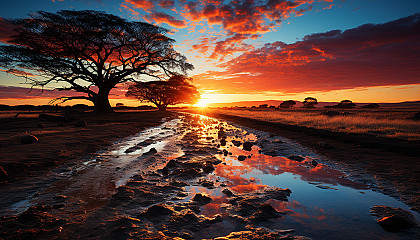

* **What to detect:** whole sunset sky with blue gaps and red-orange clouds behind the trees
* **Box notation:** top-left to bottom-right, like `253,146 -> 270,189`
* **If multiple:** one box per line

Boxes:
0,0 -> 420,105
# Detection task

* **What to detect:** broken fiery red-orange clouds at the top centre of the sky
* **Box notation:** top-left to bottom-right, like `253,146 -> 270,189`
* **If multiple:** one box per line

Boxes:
123,0 -> 332,61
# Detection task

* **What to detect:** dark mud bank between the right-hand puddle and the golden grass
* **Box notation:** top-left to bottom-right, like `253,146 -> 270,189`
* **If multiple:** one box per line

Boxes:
196,111 -> 420,212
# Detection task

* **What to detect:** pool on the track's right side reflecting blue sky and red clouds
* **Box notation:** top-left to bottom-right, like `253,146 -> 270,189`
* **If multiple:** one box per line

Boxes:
184,114 -> 419,239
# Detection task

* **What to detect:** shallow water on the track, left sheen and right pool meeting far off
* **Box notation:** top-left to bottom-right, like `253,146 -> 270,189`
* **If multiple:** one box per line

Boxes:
0,115 -> 420,239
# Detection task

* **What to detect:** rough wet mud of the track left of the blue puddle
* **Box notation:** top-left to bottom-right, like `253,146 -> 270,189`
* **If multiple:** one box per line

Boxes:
0,115 -> 312,239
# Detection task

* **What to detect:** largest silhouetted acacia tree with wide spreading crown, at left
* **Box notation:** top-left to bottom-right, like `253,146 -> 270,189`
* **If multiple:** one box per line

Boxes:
0,10 -> 193,112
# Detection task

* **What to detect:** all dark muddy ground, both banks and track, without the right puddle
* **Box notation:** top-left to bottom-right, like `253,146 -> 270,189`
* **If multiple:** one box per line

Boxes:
0,109 -> 420,239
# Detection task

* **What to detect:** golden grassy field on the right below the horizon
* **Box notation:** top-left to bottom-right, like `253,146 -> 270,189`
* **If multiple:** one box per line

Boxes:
212,108 -> 420,140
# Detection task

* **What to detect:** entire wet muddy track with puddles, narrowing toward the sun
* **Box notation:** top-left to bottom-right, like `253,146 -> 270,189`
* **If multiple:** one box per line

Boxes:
0,114 -> 418,239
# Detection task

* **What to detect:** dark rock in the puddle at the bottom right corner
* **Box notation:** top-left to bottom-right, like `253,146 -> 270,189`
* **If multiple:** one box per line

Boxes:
370,205 -> 420,232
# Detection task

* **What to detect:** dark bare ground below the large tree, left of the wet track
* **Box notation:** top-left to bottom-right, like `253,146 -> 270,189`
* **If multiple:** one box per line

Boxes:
0,111 -> 171,183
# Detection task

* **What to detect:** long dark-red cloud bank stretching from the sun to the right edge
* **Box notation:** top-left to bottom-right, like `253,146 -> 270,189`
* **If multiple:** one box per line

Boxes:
194,14 -> 420,93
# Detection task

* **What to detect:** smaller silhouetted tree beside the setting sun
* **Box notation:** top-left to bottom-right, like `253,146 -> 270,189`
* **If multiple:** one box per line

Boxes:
125,75 -> 200,111
